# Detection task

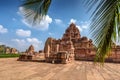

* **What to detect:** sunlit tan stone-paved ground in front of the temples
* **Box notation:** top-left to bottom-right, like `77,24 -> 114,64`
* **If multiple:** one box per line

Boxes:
0,58 -> 120,80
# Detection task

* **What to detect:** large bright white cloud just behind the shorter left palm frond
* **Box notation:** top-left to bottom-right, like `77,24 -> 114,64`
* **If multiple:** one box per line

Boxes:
19,7 -> 52,30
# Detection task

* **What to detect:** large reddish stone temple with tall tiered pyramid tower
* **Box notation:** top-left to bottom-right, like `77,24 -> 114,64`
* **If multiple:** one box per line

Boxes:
44,23 -> 95,63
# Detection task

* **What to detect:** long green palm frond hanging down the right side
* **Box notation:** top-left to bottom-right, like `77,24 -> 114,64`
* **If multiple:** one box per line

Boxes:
86,0 -> 120,62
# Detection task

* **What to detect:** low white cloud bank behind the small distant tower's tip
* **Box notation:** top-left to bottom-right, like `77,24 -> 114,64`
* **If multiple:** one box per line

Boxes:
11,38 -> 44,51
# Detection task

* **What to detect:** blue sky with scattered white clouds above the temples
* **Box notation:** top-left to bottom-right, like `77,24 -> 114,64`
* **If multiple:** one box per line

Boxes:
0,0 -> 90,51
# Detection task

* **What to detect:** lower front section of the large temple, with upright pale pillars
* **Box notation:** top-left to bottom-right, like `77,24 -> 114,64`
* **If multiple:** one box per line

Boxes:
44,38 -> 74,63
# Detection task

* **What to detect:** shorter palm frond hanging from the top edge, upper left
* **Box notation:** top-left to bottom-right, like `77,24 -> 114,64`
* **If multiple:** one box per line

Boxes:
21,0 -> 51,25
